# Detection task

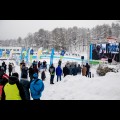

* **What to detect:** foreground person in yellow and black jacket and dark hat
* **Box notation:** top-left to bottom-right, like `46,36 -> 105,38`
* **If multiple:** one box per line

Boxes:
2,76 -> 25,100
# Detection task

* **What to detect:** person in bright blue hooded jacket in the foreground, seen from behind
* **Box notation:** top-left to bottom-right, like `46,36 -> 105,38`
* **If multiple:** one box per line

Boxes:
30,73 -> 44,100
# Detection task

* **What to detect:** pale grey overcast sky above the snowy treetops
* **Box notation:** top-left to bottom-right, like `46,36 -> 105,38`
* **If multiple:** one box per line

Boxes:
0,20 -> 116,40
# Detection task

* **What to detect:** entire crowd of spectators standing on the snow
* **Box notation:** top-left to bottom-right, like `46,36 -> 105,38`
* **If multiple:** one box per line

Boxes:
0,60 -> 91,100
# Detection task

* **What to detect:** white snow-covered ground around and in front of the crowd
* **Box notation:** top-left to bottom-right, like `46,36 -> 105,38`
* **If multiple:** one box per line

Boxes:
0,56 -> 120,100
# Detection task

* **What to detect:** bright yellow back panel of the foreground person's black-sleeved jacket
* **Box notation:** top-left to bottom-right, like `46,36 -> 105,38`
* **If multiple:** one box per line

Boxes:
4,83 -> 22,100
